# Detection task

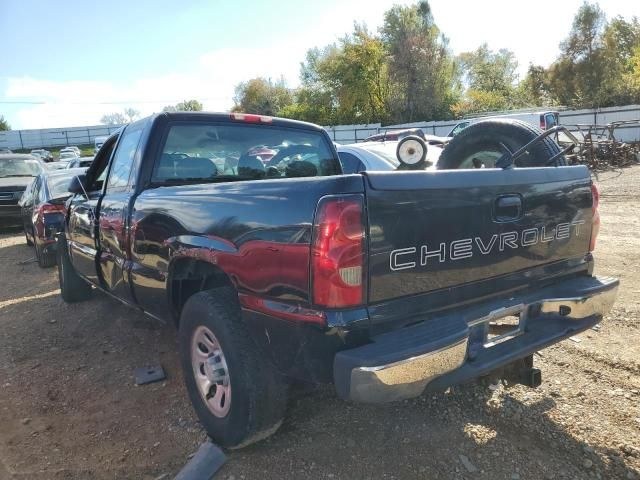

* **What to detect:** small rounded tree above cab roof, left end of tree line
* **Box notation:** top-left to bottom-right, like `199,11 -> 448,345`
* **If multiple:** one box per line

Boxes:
232,78 -> 293,115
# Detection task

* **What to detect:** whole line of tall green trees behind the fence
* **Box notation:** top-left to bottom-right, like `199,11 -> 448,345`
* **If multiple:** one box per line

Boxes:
233,0 -> 640,125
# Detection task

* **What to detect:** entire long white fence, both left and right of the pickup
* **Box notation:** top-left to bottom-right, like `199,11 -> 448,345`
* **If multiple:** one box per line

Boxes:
0,105 -> 640,150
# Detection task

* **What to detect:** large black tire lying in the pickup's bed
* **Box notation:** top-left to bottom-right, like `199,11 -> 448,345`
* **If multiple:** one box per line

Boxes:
438,119 -> 567,170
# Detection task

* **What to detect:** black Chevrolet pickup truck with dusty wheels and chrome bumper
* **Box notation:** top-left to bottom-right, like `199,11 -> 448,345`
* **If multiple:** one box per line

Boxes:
57,113 -> 618,447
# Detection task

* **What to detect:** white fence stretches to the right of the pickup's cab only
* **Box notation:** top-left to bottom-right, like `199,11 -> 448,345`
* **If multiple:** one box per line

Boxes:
325,105 -> 640,144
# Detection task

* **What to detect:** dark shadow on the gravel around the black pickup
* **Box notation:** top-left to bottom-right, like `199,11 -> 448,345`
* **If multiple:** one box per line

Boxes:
0,284 -> 635,480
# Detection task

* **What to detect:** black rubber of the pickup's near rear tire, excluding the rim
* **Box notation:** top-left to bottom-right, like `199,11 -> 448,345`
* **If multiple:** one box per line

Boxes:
179,287 -> 287,448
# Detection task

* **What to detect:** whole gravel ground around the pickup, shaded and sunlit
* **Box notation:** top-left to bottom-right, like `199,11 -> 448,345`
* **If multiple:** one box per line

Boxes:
0,167 -> 640,480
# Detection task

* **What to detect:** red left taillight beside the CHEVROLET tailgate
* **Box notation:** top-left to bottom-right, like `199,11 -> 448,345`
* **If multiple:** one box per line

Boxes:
311,195 -> 366,308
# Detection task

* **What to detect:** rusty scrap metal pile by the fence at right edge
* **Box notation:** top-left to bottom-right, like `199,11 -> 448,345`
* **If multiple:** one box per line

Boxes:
557,120 -> 640,170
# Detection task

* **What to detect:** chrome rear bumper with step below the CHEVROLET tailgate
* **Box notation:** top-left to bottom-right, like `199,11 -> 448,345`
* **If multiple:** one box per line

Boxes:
334,277 -> 619,403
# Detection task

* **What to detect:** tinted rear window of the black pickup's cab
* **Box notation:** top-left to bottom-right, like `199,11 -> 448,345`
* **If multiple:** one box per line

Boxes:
153,124 -> 340,183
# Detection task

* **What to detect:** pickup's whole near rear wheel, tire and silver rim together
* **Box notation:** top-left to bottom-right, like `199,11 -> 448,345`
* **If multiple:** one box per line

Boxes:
179,287 -> 287,448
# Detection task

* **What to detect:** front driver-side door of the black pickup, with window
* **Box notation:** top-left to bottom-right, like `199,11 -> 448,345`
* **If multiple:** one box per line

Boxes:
67,135 -> 118,285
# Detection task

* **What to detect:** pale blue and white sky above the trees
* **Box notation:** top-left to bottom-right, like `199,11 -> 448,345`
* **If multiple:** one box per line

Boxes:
0,0 -> 640,129
